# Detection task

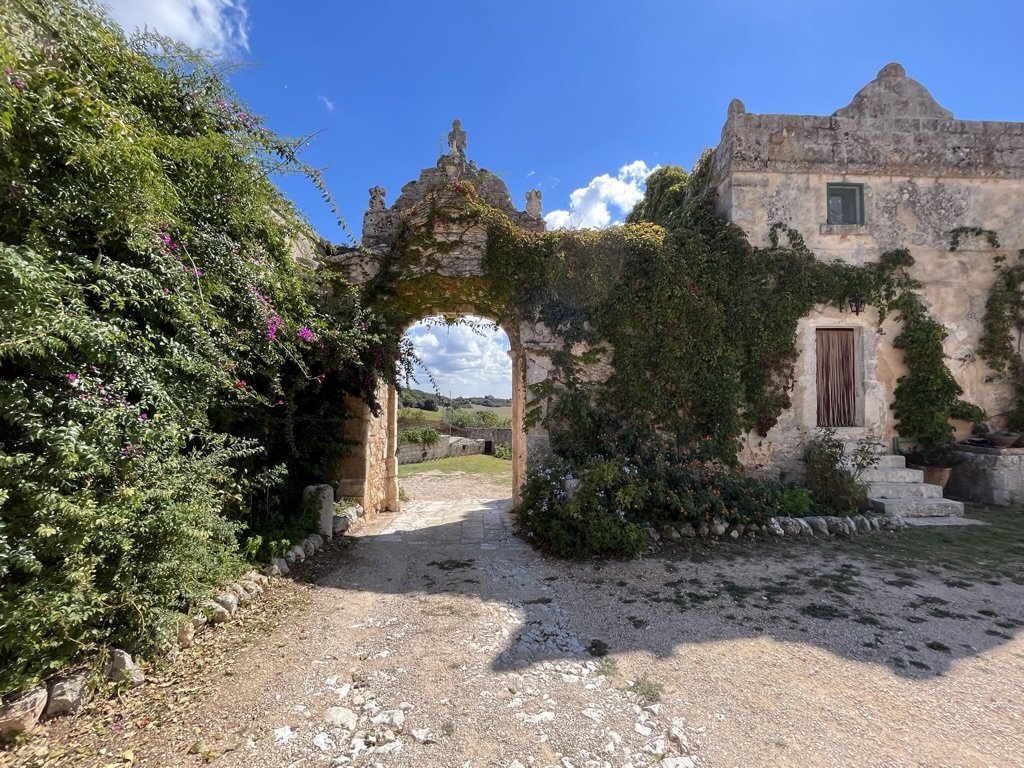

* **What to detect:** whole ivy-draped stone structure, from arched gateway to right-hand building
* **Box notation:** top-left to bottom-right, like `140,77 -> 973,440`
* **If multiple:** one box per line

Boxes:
328,63 -> 1024,514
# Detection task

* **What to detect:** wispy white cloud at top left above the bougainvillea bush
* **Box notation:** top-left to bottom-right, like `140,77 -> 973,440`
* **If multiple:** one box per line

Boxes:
102,0 -> 249,53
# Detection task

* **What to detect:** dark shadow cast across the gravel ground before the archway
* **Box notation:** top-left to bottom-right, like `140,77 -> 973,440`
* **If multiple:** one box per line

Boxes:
297,500 -> 1024,679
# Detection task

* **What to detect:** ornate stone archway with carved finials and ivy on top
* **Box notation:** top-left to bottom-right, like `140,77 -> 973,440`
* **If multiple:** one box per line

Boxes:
327,121 -> 562,513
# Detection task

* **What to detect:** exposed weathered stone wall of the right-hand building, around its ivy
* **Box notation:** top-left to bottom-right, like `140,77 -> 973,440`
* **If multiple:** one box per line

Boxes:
713,65 -> 1024,469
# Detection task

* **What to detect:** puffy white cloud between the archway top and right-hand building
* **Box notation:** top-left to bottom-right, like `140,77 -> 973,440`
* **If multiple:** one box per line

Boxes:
544,160 -> 657,229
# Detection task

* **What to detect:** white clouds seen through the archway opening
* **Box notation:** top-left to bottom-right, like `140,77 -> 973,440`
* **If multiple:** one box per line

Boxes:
407,317 -> 512,397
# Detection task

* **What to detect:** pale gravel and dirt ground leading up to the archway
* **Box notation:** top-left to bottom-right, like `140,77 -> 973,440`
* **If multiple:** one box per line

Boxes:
8,473 -> 1024,768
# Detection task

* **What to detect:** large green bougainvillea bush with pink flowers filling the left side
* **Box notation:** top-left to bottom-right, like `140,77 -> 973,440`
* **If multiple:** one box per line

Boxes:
0,0 -> 395,693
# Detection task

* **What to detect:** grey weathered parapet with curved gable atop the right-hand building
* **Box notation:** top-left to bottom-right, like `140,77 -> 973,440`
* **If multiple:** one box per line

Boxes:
714,63 -> 1024,180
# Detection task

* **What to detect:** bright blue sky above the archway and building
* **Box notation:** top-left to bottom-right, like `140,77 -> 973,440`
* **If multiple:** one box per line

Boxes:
101,0 -> 1024,394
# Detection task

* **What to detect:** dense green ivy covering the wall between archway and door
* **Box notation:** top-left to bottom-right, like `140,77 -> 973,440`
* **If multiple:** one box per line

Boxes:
450,155 -> 983,554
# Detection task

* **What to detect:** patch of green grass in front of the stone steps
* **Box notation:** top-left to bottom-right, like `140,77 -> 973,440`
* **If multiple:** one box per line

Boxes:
843,504 -> 1024,584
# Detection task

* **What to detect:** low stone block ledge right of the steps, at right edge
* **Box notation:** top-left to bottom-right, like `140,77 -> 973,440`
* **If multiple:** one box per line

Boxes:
946,445 -> 1024,507
